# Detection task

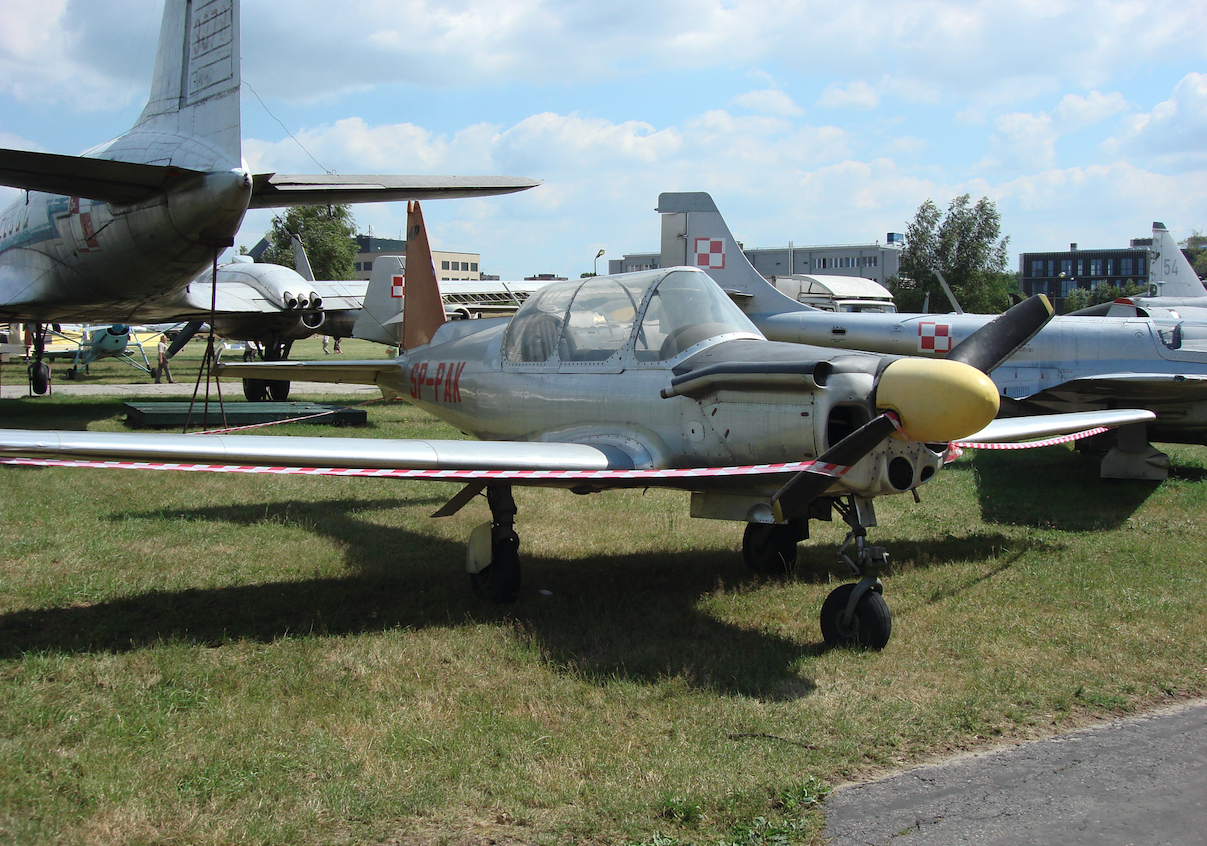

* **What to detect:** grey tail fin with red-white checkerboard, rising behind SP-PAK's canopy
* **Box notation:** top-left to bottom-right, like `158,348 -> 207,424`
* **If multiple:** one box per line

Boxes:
658,192 -> 807,314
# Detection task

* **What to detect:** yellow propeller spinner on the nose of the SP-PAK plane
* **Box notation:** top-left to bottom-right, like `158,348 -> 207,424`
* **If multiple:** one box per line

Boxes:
876,358 -> 999,443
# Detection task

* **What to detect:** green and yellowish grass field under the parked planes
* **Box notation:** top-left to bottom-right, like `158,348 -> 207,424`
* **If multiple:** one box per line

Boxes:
0,383 -> 1207,846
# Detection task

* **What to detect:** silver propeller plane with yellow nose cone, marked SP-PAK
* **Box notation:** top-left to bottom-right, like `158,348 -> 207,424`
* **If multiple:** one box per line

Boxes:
0,203 -> 1151,648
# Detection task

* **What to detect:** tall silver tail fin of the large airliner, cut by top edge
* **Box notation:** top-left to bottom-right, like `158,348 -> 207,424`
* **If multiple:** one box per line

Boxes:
128,0 -> 243,170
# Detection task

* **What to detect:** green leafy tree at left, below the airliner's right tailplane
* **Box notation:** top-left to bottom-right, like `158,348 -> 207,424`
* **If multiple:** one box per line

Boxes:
260,205 -> 356,280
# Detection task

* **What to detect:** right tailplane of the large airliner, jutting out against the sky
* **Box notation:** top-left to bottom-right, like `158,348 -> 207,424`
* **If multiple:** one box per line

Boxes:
249,174 -> 541,209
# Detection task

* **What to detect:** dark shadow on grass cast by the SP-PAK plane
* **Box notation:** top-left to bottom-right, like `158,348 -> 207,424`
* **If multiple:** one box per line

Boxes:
0,497 -> 1066,700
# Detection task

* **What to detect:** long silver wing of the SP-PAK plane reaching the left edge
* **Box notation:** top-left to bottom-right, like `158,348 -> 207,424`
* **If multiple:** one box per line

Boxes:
0,428 -> 634,473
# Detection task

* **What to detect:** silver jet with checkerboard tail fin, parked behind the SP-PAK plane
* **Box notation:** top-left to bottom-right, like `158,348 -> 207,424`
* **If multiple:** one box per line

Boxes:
658,193 -> 1207,479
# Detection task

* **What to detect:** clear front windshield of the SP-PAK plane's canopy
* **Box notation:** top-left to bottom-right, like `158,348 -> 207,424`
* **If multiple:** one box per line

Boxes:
634,270 -> 758,361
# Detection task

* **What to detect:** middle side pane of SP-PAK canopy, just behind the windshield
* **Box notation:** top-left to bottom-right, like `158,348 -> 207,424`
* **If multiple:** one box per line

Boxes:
558,276 -> 648,361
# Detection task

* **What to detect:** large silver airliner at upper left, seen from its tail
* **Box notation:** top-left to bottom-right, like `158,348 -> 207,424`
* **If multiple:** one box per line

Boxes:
0,0 -> 537,393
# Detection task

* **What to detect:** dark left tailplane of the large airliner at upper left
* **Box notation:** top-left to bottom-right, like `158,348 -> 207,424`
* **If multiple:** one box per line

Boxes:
0,150 -> 204,205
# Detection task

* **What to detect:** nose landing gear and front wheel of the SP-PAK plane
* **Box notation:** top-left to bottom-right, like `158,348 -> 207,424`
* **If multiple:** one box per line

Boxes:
821,496 -> 893,649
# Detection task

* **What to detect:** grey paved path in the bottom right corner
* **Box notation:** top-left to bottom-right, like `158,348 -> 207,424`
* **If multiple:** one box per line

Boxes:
826,702 -> 1207,846
